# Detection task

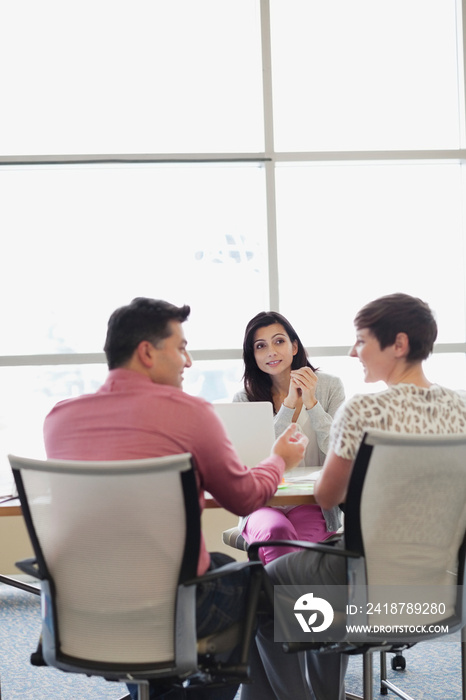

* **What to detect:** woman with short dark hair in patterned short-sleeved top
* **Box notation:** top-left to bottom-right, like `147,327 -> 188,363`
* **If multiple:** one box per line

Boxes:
241,294 -> 466,700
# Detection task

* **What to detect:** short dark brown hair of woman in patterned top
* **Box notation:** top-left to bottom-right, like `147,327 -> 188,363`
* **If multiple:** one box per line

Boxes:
354,294 -> 437,362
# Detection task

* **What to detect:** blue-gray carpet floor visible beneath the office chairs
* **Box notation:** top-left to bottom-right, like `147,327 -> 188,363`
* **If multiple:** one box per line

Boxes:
0,584 -> 462,700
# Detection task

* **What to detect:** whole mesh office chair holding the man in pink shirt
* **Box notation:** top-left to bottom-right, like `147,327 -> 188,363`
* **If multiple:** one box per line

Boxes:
9,454 -> 274,700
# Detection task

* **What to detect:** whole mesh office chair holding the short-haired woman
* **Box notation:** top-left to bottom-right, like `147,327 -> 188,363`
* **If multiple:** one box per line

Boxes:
248,431 -> 466,700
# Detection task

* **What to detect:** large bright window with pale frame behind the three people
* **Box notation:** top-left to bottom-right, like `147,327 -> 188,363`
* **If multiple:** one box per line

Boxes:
0,0 -> 466,495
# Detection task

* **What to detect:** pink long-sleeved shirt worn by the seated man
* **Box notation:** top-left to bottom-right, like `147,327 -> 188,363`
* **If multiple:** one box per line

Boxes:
44,369 -> 285,575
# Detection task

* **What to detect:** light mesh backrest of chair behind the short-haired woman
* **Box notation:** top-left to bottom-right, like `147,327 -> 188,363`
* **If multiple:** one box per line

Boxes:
345,431 -> 466,616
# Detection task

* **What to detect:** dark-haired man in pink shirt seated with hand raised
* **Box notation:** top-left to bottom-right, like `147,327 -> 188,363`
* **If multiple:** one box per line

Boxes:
44,298 -> 306,700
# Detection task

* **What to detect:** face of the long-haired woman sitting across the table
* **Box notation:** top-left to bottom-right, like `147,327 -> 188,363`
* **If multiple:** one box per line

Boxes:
253,323 -> 298,376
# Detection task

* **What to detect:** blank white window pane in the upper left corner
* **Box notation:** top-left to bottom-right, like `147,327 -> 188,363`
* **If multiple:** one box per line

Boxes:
0,0 -> 263,155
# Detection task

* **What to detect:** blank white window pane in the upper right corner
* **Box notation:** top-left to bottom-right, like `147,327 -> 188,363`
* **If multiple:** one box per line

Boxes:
271,0 -> 459,151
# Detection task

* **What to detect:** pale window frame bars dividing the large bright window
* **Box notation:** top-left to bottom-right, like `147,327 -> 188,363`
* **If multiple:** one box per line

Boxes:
0,0 -> 466,367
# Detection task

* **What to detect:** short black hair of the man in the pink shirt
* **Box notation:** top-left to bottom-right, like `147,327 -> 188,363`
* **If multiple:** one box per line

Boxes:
104,297 -> 191,369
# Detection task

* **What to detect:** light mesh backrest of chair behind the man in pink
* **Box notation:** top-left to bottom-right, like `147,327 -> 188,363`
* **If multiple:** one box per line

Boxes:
9,454 -> 200,668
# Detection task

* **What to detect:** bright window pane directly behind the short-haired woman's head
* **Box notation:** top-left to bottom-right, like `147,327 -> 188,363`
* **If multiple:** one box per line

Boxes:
276,164 -> 465,346
